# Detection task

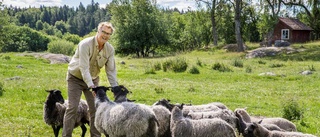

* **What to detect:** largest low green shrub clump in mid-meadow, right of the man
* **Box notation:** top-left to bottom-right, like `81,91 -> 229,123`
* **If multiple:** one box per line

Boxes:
162,57 -> 188,72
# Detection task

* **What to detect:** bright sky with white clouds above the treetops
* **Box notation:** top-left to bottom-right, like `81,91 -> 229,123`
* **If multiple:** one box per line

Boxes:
3,0 -> 196,10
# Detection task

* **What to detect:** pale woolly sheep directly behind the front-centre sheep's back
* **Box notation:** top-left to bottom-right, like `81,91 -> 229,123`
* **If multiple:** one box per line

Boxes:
186,109 -> 239,128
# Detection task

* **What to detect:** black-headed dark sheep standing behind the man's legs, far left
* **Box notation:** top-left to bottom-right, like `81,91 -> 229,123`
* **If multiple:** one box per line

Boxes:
43,89 -> 89,137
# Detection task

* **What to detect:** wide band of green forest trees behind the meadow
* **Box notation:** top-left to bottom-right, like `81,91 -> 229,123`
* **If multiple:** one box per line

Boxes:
0,0 -> 320,57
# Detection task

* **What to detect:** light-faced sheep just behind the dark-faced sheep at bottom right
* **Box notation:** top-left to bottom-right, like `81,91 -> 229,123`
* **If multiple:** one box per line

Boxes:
235,109 -> 297,131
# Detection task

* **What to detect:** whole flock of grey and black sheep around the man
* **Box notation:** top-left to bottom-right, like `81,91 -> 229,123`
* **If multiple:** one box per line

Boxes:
44,85 -> 316,137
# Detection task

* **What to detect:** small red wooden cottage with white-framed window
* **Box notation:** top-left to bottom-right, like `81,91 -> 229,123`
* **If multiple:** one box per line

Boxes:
272,18 -> 313,43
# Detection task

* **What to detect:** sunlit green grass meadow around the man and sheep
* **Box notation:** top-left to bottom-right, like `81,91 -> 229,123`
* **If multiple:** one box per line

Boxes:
0,42 -> 320,137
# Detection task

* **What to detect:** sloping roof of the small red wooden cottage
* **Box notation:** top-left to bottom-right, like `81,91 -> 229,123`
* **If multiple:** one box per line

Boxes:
279,18 -> 313,30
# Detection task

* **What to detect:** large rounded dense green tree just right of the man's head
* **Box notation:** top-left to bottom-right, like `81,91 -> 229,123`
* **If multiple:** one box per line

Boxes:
110,0 -> 166,57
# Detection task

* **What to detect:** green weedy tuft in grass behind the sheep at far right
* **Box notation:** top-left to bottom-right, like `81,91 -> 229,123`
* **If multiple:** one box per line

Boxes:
282,99 -> 304,121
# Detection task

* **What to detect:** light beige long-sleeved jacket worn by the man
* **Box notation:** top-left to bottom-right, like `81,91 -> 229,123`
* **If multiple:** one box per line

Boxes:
68,36 -> 118,87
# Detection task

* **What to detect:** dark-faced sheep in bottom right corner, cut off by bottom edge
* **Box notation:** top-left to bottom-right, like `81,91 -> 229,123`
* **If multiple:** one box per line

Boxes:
245,122 -> 316,137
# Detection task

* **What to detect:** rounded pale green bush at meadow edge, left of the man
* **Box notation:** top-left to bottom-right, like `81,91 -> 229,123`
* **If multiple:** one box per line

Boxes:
48,40 -> 74,55
